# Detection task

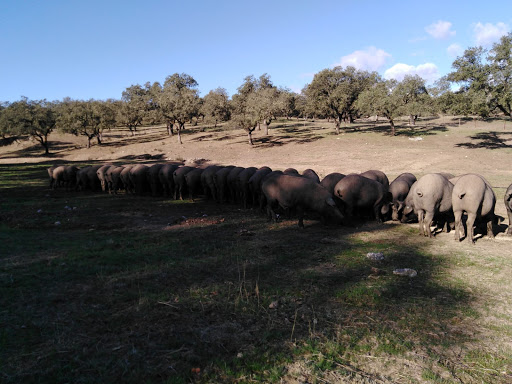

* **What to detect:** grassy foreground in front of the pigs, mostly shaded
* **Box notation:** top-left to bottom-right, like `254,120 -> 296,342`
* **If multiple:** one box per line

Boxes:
0,118 -> 512,383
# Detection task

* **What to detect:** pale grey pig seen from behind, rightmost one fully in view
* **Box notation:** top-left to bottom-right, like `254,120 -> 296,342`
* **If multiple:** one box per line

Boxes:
452,173 -> 496,244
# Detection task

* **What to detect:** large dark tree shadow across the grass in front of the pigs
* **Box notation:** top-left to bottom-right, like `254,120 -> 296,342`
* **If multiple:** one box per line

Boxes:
0,165 -> 488,382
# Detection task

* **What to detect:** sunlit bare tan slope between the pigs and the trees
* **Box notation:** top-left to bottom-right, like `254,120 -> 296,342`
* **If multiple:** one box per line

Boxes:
0,117 -> 512,208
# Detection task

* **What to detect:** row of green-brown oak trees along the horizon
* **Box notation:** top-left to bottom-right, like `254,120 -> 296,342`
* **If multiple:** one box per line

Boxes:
4,33 -> 512,149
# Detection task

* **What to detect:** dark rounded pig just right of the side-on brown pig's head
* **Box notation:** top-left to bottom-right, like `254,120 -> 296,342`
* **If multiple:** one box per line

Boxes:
334,174 -> 393,222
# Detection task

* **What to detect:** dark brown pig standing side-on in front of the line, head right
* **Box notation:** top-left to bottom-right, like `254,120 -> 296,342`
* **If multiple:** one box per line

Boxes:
261,174 -> 343,228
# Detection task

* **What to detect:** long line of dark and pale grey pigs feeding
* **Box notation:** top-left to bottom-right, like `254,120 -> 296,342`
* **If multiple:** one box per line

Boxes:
48,164 -> 512,243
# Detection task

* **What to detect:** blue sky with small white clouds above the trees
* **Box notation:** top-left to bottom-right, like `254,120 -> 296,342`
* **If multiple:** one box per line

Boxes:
0,0 -> 512,101
